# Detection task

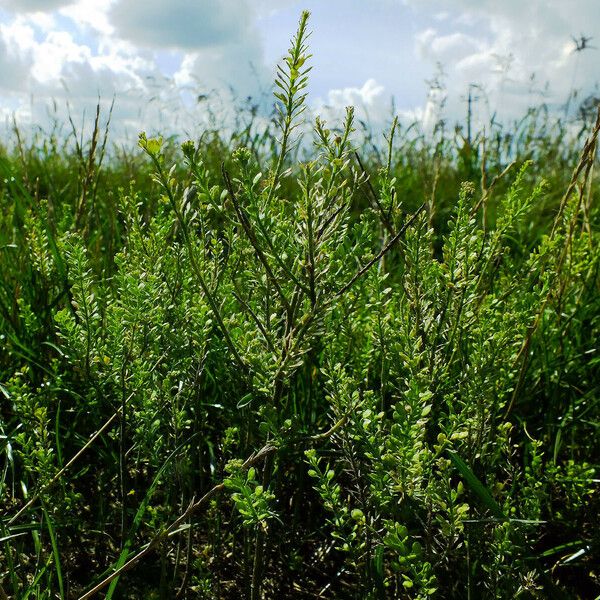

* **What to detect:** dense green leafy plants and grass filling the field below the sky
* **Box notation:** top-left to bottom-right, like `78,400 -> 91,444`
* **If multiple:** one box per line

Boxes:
0,14 -> 600,600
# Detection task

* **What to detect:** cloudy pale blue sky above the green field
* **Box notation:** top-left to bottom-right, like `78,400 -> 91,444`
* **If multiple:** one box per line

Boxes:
0,0 -> 600,139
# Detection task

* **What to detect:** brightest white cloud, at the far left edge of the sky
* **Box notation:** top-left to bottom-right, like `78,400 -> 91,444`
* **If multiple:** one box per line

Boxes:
0,8 -> 164,140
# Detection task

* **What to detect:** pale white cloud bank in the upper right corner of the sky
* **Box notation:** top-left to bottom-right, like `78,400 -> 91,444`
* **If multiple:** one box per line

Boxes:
409,0 -> 600,116
